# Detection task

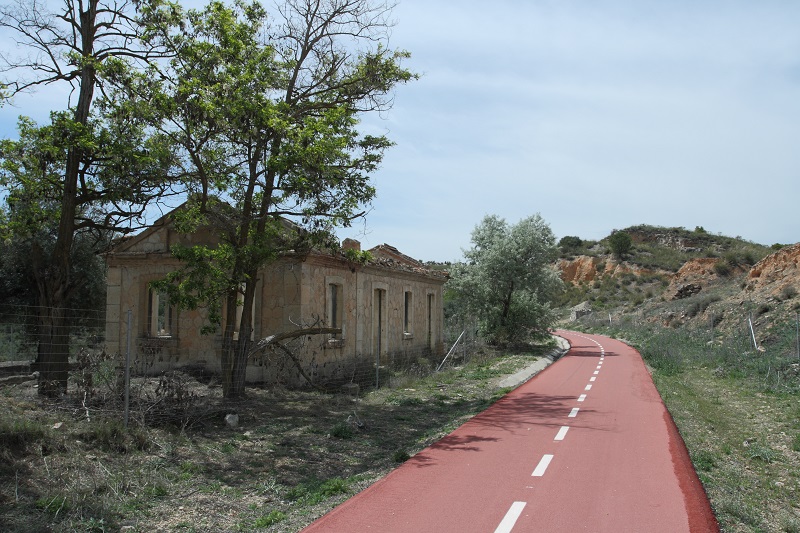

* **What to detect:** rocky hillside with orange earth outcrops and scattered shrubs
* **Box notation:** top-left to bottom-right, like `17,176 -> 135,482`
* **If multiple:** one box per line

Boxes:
557,226 -> 800,334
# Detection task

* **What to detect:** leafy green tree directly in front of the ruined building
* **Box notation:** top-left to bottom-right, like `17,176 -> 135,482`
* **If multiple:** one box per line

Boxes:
146,0 -> 415,398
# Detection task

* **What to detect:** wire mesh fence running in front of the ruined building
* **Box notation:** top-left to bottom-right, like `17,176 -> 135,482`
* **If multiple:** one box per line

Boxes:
0,306 -> 484,403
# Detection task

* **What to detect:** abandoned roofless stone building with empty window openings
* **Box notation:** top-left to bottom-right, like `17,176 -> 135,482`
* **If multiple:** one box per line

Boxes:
106,213 -> 447,386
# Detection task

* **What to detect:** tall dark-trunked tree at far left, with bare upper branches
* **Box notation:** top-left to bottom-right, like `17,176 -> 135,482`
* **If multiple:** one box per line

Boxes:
0,0 -> 177,396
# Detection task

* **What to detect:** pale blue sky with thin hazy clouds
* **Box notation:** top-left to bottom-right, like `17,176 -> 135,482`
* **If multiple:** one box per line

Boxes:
0,0 -> 800,261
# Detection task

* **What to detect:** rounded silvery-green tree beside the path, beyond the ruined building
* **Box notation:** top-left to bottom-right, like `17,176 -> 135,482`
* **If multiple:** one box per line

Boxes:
449,215 -> 563,344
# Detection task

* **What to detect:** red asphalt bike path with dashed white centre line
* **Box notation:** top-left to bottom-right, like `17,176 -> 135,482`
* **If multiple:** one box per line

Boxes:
303,331 -> 719,533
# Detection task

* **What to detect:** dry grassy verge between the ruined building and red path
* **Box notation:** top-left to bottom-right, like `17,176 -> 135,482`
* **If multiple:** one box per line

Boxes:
0,342 -> 545,533
